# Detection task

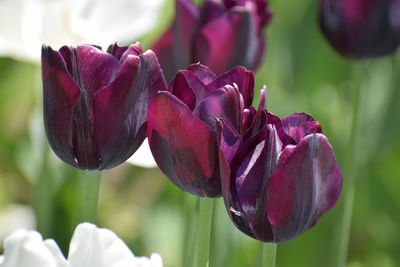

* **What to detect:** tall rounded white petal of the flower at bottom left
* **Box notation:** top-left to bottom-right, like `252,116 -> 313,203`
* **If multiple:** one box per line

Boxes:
68,223 -> 135,267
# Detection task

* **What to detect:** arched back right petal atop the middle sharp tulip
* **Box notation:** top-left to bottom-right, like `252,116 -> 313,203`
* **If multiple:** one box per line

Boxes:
209,67 -> 254,108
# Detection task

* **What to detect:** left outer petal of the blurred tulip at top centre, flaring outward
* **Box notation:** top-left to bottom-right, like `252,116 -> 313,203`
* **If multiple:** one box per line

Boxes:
151,27 -> 177,82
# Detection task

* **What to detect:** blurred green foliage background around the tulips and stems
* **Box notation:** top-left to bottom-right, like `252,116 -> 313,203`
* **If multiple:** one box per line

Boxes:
0,0 -> 400,267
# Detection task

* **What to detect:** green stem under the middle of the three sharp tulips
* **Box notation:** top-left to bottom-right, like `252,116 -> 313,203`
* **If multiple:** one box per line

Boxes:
196,198 -> 214,267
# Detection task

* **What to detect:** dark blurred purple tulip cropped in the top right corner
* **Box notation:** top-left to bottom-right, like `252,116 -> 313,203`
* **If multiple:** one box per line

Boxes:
319,0 -> 400,59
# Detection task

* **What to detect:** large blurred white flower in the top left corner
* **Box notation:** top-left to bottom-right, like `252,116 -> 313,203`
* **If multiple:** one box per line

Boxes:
0,0 -> 164,62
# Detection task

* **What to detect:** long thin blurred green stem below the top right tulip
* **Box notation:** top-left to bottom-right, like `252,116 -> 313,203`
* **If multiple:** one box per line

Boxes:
337,65 -> 364,267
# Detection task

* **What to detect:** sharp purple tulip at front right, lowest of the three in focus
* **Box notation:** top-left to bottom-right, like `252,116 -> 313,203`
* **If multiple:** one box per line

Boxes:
218,90 -> 342,242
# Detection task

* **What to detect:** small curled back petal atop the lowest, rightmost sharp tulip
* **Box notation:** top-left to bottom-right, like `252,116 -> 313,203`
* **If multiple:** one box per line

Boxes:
281,113 -> 322,143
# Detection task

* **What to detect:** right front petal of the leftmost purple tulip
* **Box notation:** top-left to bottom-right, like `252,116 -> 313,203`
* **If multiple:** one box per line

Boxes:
92,50 -> 167,169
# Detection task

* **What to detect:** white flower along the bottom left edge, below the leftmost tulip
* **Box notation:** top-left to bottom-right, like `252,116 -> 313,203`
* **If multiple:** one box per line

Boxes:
0,223 -> 163,267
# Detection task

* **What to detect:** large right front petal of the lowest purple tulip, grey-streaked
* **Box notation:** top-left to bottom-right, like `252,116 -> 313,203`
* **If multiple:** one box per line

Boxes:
266,133 -> 342,242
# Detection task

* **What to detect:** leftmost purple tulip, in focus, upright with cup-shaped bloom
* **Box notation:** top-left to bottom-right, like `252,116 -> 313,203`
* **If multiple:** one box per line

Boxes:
42,43 -> 167,170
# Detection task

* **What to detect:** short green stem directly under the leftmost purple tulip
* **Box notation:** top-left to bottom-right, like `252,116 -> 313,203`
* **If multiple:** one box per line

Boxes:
81,171 -> 101,223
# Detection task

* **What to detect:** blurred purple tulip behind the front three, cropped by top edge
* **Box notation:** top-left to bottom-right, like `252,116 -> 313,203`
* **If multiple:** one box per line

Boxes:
152,0 -> 272,80
